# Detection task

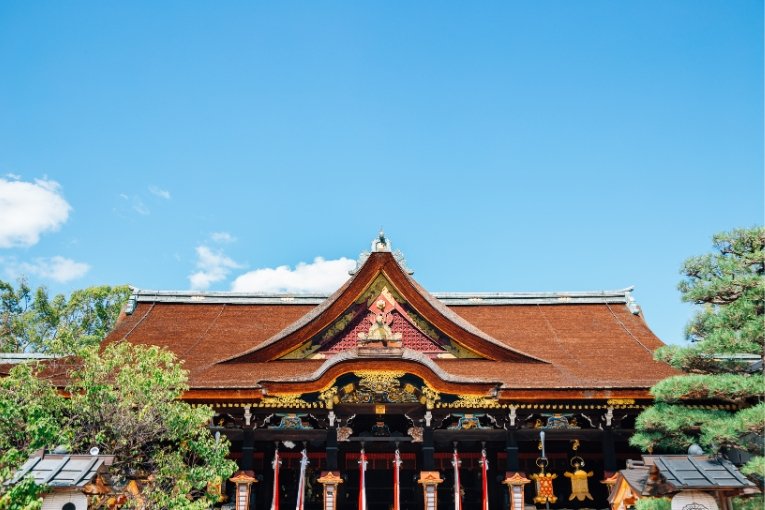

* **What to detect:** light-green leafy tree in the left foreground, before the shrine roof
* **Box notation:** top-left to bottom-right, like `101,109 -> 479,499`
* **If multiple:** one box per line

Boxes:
0,342 -> 235,510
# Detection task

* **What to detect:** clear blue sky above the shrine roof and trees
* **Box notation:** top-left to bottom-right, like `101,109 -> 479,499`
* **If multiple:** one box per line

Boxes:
0,0 -> 763,342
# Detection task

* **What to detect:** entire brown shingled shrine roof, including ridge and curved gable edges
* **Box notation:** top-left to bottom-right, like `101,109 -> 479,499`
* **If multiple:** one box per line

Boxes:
100,239 -> 675,399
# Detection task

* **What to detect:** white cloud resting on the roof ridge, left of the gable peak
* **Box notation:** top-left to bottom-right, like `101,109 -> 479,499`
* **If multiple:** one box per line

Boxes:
231,257 -> 356,293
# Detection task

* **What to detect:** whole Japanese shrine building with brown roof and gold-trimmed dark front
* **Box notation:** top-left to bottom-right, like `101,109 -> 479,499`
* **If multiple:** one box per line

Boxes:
107,233 -> 676,510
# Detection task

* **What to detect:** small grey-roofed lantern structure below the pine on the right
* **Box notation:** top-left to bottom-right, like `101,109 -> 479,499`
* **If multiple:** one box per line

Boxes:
608,455 -> 759,510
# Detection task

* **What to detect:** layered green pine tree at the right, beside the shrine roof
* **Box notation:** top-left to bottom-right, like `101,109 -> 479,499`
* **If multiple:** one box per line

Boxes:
631,227 -> 765,492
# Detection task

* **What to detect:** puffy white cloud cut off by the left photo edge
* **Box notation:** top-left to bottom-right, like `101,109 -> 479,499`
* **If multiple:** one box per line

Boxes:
0,177 -> 72,248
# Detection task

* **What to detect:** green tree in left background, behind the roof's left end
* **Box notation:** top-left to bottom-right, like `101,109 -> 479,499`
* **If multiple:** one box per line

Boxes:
0,280 -> 130,355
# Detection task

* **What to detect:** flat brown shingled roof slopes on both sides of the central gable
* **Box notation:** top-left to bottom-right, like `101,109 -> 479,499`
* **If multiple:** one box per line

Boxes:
104,301 -> 674,388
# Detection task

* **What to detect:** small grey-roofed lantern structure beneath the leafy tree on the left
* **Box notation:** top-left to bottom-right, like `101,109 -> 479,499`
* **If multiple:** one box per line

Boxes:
8,450 -> 114,510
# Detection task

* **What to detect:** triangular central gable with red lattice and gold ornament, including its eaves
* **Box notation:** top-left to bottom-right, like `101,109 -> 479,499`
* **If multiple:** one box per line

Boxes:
224,237 -> 546,363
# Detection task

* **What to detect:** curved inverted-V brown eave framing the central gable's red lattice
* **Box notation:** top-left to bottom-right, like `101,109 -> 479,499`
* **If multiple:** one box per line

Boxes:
221,252 -> 548,363
